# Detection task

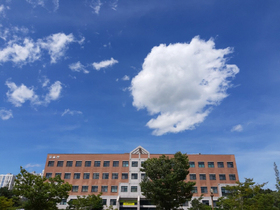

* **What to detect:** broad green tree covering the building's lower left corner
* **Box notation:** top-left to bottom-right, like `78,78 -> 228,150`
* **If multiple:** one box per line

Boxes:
14,167 -> 72,210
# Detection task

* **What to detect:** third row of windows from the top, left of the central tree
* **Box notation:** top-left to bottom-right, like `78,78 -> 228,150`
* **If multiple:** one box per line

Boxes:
72,185 -> 138,193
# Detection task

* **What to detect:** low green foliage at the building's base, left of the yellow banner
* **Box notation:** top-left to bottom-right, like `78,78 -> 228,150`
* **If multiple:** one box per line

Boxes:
67,193 -> 103,210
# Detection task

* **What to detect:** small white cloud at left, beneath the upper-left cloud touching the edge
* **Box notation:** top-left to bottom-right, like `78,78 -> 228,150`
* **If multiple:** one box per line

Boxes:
6,81 -> 38,107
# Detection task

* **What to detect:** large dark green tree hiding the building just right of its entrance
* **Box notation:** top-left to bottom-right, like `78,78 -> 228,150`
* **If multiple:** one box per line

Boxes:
140,152 -> 195,210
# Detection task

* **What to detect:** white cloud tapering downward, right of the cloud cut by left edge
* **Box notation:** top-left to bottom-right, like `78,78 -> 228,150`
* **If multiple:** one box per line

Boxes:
40,33 -> 74,63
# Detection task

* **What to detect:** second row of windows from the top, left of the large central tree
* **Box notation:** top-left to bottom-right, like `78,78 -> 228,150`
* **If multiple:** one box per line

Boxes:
46,173 -> 145,179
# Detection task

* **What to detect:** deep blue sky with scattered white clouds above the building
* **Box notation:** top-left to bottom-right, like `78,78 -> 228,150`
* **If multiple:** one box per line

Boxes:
0,0 -> 280,188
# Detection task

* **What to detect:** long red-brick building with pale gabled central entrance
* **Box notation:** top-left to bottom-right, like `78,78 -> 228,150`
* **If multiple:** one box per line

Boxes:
44,146 -> 238,210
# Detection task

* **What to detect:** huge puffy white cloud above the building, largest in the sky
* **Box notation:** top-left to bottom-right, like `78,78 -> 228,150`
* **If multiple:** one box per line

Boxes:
130,37 -> 239,135
